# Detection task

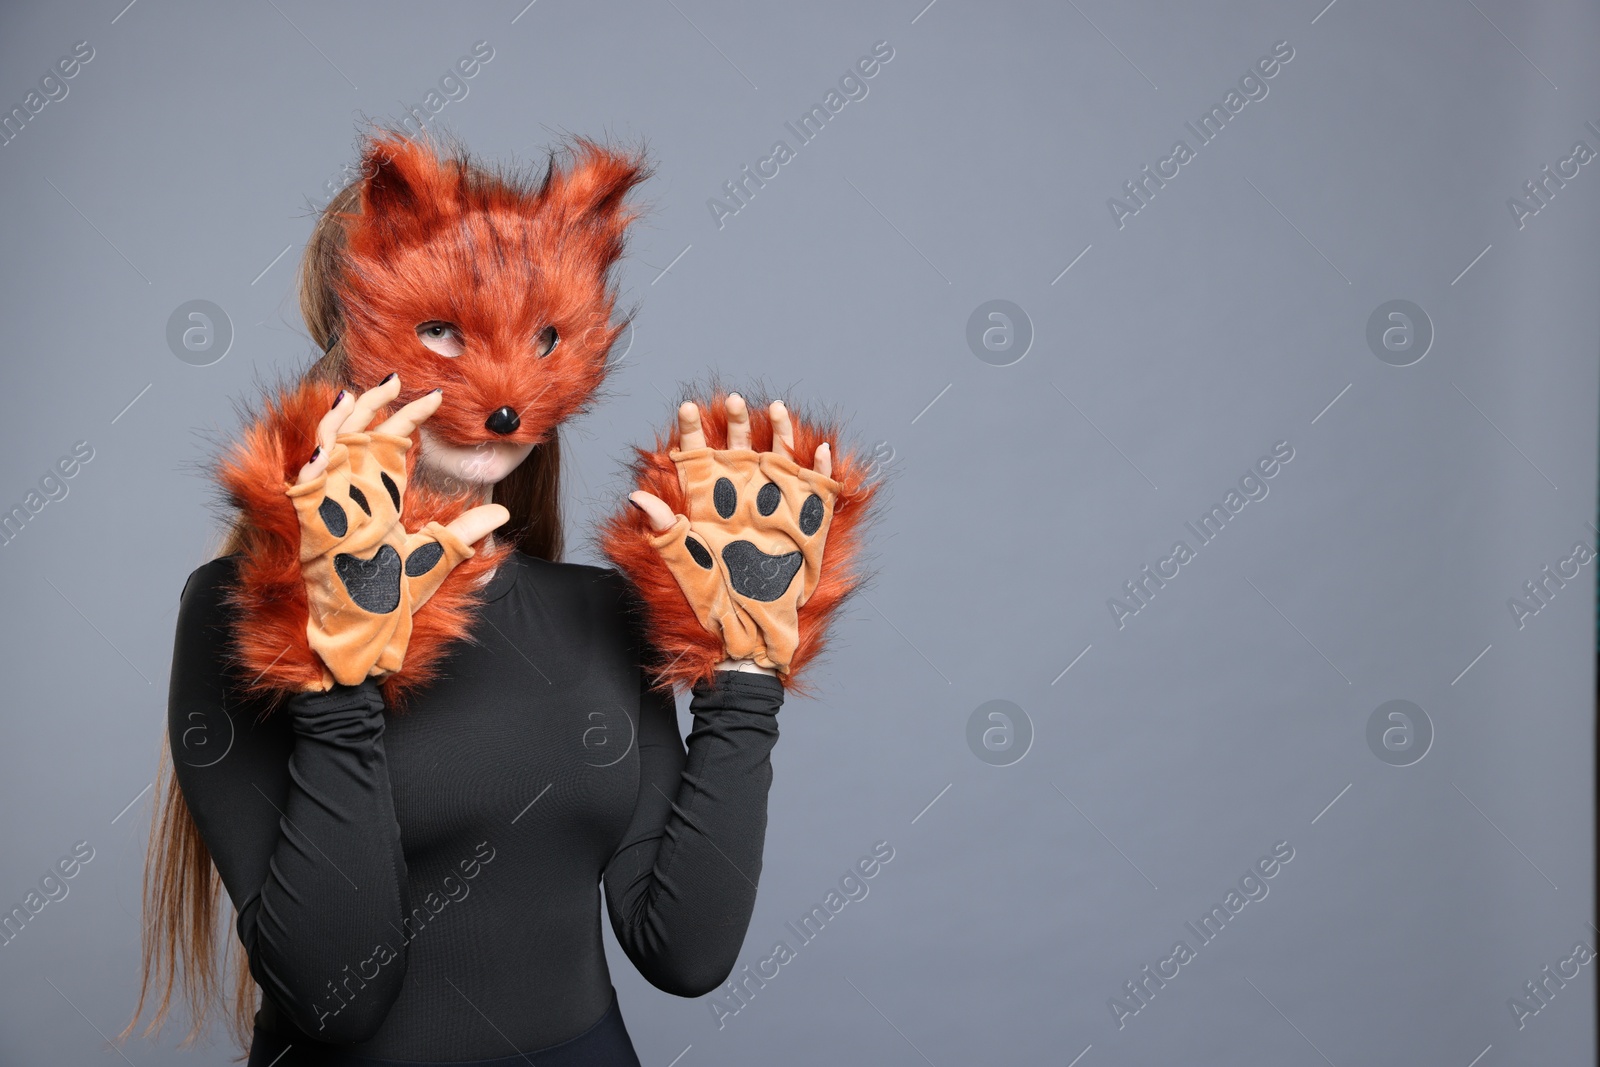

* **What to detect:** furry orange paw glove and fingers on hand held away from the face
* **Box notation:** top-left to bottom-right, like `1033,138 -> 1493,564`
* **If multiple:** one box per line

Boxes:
598,387 -> 882,694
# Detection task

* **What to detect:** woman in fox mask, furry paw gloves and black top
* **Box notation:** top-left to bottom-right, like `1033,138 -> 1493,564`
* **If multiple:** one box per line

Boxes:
123,134 -> 872,1067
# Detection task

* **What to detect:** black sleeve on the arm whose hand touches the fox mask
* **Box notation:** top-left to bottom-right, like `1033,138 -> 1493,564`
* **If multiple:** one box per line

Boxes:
168,558 -> 408,1043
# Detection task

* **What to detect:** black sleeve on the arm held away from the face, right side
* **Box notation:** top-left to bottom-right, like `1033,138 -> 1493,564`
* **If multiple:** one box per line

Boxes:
605,572 -> 784,997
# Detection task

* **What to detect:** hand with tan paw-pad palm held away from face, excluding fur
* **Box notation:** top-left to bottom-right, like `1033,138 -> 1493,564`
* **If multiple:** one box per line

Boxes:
629,394 -> 840,675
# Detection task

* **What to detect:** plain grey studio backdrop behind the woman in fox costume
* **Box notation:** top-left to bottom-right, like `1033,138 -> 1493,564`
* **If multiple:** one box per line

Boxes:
0,0 -> 1600,1067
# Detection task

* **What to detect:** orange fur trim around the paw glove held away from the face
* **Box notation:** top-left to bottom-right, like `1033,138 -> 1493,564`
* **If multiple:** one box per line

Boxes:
598,389 -> 882,694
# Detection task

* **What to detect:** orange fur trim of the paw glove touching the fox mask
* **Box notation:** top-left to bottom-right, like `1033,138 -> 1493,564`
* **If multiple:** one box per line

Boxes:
218,381 -> 512,707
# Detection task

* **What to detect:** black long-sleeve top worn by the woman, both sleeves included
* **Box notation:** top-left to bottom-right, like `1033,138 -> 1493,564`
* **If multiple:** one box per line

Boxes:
168,552 -> 784,1061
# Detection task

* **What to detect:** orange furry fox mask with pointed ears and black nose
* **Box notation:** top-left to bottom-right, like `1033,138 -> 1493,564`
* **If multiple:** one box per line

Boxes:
334,134 -> 650,446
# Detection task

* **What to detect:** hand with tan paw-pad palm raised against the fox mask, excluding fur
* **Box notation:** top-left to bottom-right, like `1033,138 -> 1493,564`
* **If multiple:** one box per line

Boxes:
286,374 -> 510,689
